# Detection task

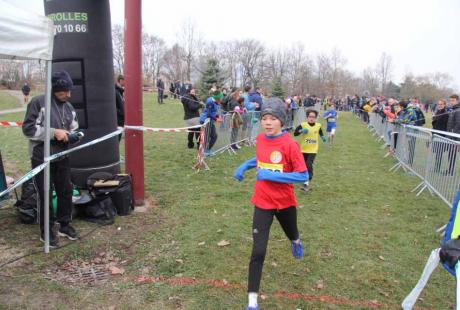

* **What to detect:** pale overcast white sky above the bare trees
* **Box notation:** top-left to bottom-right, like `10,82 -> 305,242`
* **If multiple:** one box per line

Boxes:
6,0 -> 460,89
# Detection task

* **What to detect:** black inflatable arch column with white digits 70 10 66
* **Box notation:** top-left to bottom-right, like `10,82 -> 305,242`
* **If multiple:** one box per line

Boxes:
44,0 -> 120,187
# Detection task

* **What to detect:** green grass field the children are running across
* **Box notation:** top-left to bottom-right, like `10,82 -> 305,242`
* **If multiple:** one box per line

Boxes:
0,94 -> 455,309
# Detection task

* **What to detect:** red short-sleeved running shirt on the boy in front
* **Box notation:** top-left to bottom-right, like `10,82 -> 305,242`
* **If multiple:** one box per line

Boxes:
251,133 -> 307,210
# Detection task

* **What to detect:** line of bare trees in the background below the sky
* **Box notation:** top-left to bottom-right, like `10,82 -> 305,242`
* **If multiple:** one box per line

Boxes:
0,21 -> 454,100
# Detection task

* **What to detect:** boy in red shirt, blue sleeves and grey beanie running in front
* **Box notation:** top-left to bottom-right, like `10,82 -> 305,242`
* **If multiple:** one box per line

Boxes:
235,98 -> 308,310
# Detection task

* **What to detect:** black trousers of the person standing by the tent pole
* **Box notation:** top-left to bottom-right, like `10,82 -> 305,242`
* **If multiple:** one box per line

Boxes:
32,157 -> 72,232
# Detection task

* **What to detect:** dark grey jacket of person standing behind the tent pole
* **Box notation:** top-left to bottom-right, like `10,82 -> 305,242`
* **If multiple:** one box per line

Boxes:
22,95 -> 78,161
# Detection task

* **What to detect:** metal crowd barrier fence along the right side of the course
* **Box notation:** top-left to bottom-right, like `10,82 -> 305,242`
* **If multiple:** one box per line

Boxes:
369,113 -> 460,208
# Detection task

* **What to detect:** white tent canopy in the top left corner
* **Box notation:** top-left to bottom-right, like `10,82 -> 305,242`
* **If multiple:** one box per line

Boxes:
0,0 -> 54,60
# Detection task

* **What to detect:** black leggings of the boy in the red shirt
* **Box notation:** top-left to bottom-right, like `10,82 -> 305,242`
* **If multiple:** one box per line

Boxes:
248,207 -> 299,293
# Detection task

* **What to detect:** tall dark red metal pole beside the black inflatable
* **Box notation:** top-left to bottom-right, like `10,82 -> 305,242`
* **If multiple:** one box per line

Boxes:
124,0 -> 145,206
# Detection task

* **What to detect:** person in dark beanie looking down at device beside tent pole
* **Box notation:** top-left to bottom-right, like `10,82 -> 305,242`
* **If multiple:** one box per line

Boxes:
22,71 -> 83,248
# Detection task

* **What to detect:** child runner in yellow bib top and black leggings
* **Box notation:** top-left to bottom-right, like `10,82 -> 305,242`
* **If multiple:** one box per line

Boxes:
294,109 -> 326,192
